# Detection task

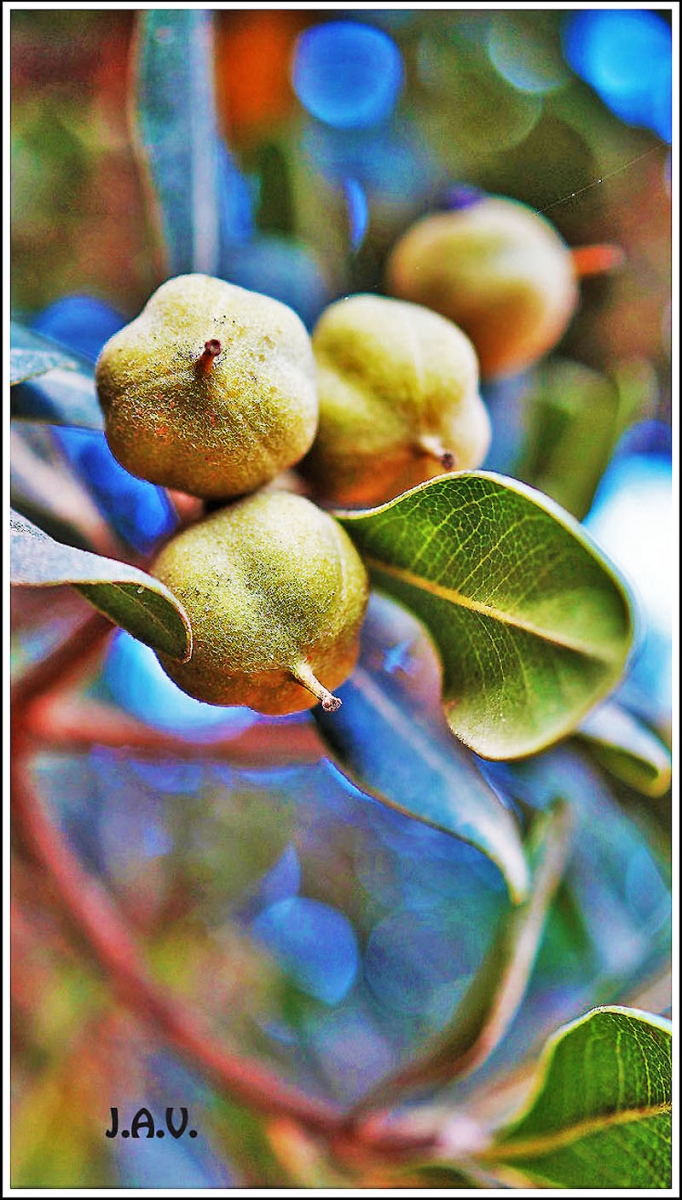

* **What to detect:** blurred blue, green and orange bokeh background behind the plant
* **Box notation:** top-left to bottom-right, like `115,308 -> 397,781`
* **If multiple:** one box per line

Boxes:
11,8 -> 672,1188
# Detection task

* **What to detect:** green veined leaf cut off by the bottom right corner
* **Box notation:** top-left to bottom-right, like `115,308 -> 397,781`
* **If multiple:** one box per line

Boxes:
480,1006 -> 672,1189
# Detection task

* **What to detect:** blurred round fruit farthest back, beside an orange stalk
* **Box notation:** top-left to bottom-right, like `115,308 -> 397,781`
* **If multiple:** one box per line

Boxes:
387,197 -> 579,378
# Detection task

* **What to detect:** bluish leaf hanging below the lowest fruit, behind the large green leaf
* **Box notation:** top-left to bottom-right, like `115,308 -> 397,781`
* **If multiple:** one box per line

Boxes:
313,596 -> 528,902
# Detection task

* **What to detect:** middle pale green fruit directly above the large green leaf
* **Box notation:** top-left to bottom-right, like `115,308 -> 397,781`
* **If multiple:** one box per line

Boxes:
301,294 -> 491,506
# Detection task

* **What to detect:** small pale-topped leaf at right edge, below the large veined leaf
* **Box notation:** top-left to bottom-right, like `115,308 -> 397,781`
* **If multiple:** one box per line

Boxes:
576,701 -> 672,797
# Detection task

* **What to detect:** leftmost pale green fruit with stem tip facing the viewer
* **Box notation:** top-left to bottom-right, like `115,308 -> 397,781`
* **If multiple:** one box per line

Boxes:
95,275 -> 318,499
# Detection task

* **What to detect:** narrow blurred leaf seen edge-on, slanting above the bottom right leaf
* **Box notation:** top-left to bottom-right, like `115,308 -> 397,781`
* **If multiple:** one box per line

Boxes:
359,800 -> 572,1110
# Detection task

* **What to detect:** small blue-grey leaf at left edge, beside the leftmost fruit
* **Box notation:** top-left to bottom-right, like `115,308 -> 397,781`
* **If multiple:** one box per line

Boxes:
10,320 -> 103,430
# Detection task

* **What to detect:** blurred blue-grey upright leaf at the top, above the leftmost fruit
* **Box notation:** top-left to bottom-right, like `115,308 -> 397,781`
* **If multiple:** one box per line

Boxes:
136,8 -> 220,275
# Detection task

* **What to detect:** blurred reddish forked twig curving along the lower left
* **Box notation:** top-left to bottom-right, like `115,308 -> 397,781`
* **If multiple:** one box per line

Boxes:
11,595 -> 437,1162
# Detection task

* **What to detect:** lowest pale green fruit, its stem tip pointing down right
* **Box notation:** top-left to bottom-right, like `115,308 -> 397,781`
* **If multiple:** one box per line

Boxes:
151,488 -> 369,715
